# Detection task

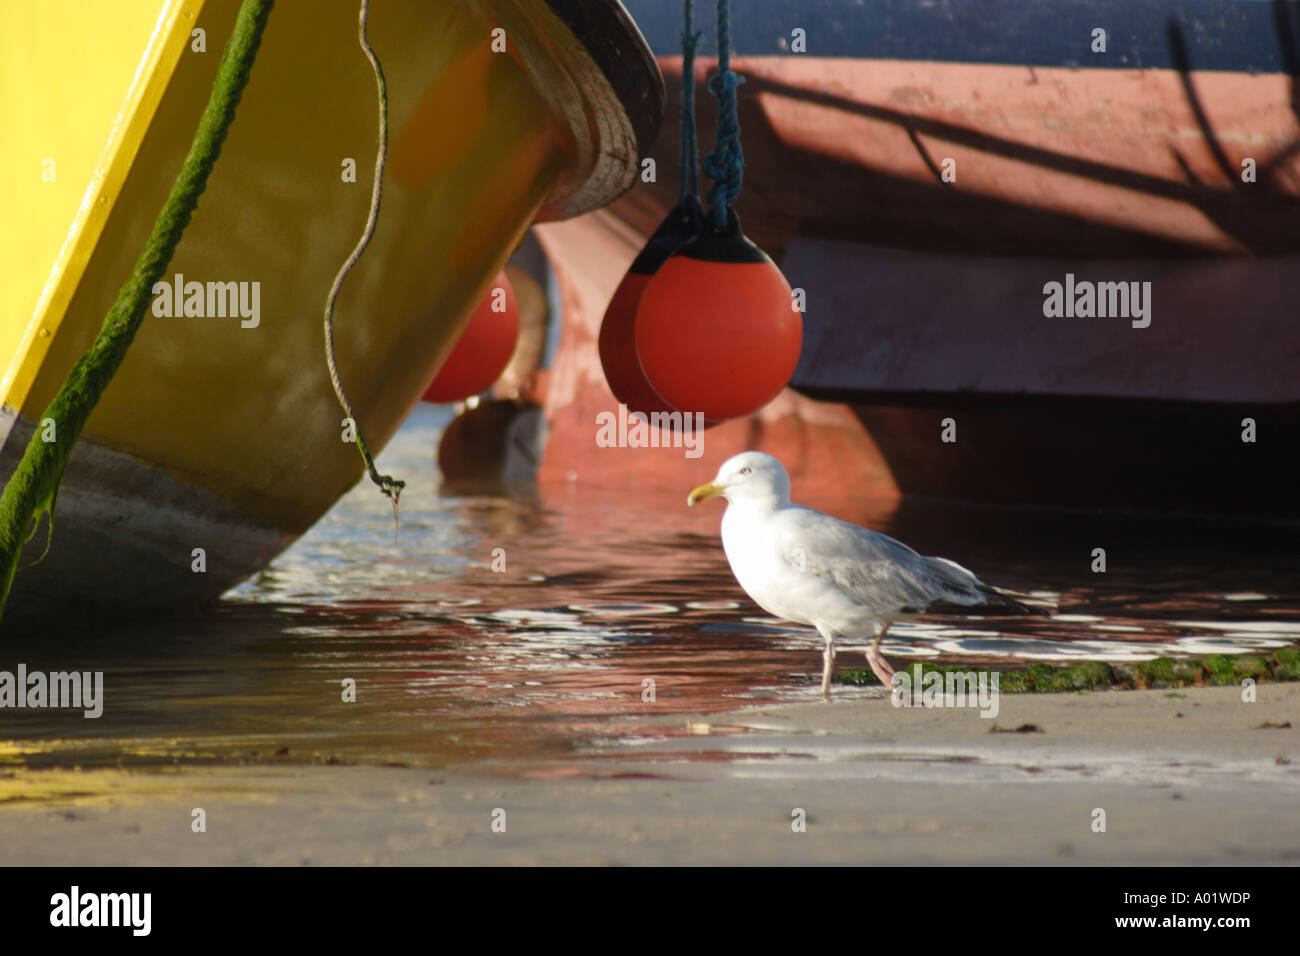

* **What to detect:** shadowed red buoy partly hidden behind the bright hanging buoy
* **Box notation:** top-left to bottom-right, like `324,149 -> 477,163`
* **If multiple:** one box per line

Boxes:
597,194 -> 705,415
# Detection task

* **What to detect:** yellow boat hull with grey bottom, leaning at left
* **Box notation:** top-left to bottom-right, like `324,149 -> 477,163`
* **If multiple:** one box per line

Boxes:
0,0 -> 663,628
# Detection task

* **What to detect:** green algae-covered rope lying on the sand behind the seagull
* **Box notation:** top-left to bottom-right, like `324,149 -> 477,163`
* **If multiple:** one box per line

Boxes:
835,646 -> 1300,693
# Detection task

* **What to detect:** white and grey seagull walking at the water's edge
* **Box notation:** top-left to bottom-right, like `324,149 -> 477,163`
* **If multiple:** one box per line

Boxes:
686,451 -> 1049,698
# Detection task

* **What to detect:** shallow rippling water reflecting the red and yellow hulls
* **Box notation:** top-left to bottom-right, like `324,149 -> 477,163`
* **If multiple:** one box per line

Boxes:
0,406 -> 1300,771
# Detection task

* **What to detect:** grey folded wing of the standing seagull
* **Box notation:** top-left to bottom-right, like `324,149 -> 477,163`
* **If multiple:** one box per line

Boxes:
781,506 -> 992,617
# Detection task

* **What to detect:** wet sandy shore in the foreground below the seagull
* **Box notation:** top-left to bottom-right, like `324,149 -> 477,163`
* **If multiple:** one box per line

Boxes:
0,683 -> 1300,865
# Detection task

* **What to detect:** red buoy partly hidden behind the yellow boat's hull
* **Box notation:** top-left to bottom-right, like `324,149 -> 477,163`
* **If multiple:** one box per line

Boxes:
421,271 -> 519,403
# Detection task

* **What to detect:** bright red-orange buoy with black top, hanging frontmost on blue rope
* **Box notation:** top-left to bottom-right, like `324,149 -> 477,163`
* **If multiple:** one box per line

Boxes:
636,212 -> 803,421
